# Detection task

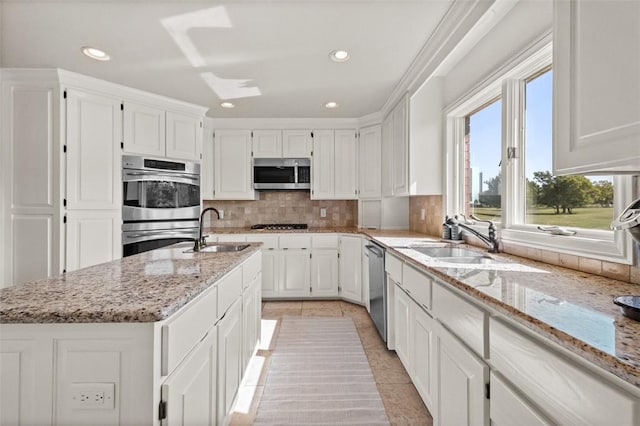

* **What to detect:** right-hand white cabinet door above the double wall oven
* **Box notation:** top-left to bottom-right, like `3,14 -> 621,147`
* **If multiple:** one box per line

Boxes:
167,112 -> 202,161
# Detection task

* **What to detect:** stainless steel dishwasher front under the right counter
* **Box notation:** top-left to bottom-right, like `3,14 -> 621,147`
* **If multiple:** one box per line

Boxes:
365,242 -> 387,342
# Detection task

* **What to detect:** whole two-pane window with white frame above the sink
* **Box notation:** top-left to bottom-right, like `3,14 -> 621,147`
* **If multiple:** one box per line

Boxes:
446,42 -> 632,263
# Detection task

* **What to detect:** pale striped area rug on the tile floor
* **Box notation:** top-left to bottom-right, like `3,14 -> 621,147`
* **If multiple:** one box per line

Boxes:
255,316 -> 389,426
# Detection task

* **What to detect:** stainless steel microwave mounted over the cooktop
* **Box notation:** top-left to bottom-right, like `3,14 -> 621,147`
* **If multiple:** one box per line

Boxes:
253,158 -> 311,189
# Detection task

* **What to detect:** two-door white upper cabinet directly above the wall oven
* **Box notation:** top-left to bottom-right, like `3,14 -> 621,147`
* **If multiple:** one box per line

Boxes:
122,99 -> 203,161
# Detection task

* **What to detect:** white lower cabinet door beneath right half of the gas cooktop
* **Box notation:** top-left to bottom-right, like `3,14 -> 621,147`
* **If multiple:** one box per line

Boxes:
278,249 -> 311,297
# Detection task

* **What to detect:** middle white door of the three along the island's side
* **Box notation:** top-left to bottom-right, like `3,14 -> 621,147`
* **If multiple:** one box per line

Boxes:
217,299 -> 242,425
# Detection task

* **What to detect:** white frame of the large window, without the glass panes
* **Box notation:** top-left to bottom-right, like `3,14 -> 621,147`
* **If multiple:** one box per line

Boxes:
445,33 -> 633,265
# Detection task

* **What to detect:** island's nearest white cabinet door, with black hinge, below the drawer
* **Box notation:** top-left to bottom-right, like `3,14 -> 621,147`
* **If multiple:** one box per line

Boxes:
161,327 -> 218,426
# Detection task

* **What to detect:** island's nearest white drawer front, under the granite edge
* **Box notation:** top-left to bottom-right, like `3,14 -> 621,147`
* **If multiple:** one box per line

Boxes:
161,286 -> 219,376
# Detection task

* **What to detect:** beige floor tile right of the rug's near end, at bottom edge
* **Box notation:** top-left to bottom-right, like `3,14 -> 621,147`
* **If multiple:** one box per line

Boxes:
378,383 -> 433,426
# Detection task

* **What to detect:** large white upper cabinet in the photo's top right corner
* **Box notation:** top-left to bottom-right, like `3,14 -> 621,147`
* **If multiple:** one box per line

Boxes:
553,1 -> 640,174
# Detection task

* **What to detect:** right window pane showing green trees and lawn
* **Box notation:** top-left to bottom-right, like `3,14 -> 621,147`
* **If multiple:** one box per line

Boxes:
524,68 -> 614,232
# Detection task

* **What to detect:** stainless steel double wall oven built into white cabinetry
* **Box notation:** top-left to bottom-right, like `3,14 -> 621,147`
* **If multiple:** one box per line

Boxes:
122,155 -> 200,256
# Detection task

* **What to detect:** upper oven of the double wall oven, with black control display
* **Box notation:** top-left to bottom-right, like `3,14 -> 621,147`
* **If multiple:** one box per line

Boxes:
122,155 -> 200,222
